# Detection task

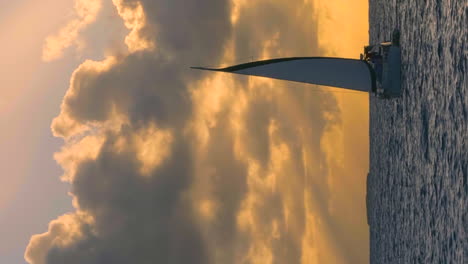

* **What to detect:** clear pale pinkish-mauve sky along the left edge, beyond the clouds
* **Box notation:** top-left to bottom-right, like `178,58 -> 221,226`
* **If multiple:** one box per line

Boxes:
0,1 -> 74,264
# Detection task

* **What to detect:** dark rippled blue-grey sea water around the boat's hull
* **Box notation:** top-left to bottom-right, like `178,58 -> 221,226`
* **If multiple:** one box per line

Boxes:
367,0 -> 468,264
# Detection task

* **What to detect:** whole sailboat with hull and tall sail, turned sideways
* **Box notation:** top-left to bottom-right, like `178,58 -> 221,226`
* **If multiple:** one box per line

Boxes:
191,30 -> 401,99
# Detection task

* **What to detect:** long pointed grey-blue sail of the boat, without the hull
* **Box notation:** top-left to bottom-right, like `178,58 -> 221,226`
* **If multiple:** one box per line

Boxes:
192,57 -> 375,92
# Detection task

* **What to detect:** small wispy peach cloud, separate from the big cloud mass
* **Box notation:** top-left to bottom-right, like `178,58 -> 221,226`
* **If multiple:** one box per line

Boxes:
42,0 -> 102,61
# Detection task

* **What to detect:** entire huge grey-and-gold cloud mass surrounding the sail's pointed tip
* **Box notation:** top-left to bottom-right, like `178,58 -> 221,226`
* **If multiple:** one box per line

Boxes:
25,0 -> 370,264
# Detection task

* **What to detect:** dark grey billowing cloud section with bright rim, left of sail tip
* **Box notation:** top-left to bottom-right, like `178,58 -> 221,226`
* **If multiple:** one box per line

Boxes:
25,1 -> 230,263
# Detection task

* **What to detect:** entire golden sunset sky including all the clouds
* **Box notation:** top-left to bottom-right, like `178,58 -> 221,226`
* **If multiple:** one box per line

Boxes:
0,0 -> 369,264
